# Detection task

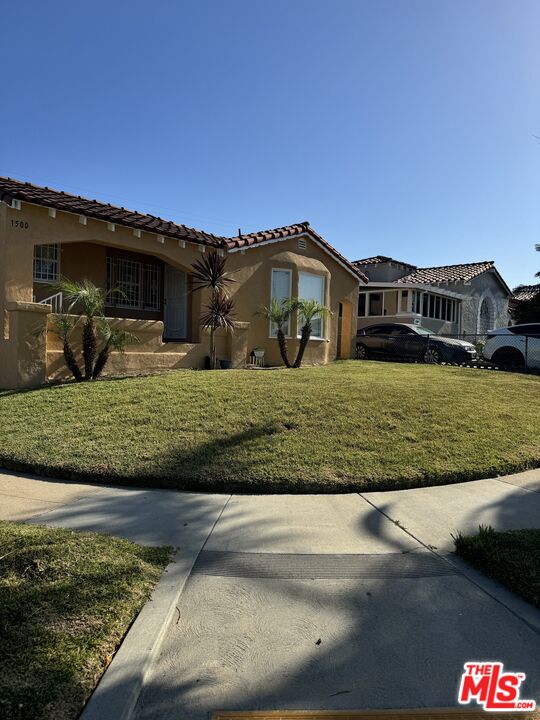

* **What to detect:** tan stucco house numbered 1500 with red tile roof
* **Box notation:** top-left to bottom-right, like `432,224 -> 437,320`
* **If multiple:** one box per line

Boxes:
0,178 -> 367,388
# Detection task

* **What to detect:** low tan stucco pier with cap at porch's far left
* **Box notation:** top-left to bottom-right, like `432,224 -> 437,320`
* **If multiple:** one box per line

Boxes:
0,302 -> 52,389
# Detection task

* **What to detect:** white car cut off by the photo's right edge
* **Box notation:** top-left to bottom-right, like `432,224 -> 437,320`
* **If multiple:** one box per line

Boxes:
482,323 -> 540,369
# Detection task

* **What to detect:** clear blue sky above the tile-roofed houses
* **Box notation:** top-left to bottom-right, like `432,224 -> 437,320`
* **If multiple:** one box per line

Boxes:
0,0 -> 540,285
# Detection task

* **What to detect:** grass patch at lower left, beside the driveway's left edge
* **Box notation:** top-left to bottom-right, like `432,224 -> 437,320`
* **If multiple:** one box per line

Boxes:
0,522 -> 170,720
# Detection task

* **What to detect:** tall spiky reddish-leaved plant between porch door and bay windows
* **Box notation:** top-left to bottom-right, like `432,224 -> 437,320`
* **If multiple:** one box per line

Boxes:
191,251 -> 236,370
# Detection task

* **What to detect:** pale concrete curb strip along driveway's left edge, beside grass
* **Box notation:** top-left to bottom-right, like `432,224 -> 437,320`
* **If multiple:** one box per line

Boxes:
80,543 -> 192,720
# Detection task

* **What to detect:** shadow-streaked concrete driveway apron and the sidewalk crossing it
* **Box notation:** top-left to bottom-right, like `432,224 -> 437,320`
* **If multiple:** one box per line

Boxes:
0,471 -> 540,720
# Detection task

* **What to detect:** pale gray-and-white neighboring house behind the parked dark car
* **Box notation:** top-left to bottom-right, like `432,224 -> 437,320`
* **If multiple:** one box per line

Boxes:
354,255 -> 512,335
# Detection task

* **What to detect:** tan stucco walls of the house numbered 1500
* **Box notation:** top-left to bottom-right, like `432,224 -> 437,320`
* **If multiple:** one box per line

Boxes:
0,197 -> 358,387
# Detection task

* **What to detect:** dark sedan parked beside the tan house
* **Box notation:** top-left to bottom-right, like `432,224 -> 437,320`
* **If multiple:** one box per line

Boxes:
356,323 -> 478,363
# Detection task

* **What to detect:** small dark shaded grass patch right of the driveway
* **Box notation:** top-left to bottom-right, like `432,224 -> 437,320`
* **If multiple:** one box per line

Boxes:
455,527 -> 540,609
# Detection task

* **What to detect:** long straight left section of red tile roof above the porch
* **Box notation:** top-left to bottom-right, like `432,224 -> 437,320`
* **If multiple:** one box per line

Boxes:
0,177 -> 225,247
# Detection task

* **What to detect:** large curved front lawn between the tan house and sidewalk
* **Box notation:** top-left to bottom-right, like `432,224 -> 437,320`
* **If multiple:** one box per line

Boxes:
0,361 -> 540,492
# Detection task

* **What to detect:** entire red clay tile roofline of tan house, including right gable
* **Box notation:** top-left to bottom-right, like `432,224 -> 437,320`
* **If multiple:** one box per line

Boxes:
0,177 -> 367,283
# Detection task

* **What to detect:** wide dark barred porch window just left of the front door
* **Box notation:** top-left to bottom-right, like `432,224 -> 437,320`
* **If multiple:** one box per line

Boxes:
107,255 -> 161,310
